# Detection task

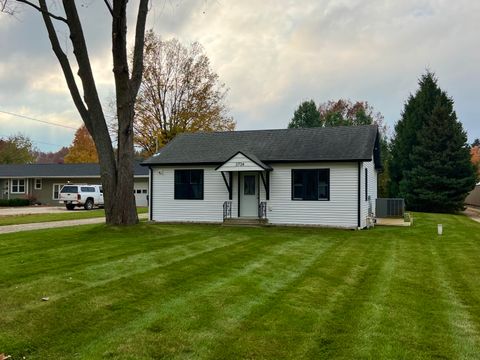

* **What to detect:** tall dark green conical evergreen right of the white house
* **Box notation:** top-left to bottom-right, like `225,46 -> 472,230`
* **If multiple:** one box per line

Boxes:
391,72 -> 475,212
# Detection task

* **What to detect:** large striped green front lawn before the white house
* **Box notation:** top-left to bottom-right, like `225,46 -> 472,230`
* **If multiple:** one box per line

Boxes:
0,214 -> 480,359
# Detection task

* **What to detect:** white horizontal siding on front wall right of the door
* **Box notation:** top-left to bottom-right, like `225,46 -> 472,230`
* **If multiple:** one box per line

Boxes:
267,163 -> 358,228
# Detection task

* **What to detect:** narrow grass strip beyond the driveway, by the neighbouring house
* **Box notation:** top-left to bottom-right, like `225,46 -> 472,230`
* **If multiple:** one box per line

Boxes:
0,207 -> 148,226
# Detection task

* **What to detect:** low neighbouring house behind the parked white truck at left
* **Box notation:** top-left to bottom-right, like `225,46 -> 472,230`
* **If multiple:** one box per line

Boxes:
0,163 -> 148,206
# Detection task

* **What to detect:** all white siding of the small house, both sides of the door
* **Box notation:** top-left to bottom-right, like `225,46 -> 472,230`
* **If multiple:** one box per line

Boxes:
151,162 -> 364,228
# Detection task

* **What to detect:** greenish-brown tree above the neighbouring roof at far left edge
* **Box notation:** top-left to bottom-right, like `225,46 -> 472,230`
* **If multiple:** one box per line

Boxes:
0,134 -> 35,164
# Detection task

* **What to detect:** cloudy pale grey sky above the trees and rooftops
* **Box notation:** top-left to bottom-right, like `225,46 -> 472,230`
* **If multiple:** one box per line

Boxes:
0,0 -> 480,151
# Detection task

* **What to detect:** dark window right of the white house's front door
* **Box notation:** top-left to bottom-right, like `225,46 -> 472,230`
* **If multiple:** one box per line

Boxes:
292,169 -> 330,200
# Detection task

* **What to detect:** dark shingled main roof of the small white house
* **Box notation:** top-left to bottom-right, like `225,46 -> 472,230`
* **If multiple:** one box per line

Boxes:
142,125 -> 378,166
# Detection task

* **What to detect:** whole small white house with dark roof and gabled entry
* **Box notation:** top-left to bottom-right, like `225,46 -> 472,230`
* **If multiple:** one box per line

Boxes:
142,126 -> 381,228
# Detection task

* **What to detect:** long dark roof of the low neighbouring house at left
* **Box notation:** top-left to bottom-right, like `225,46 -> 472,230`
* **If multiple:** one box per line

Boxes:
0,163 -> 148,178
